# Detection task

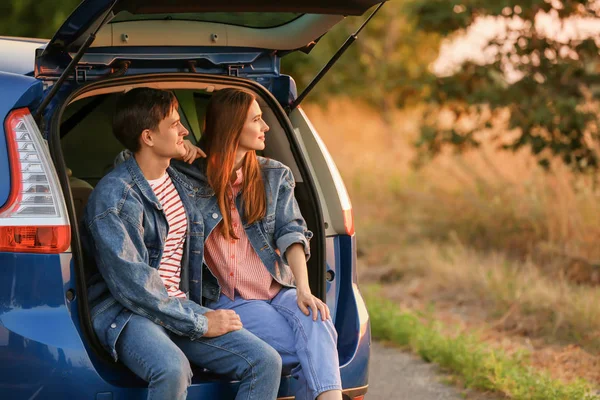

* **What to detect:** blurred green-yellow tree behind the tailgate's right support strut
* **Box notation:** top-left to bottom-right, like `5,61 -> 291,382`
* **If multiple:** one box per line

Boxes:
282,1 -> 440,115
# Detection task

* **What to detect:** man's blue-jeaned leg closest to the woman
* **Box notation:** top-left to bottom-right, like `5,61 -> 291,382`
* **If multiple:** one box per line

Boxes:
171,329 -> 281,400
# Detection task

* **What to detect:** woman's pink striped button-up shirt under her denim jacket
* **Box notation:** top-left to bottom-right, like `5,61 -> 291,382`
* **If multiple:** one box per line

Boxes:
205,169 -> 281,300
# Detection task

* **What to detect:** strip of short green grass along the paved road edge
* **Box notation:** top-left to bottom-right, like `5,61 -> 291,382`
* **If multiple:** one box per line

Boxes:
365,287 -> 600,400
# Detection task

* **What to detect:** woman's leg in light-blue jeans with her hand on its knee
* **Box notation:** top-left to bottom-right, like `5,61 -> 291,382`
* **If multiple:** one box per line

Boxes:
271,289 -> 342,400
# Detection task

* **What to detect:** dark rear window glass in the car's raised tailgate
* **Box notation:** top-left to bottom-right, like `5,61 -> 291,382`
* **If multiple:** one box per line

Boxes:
110,11 -> 303,28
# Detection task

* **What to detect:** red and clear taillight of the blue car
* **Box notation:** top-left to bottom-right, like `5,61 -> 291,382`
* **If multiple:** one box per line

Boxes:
0,108 -> 71,253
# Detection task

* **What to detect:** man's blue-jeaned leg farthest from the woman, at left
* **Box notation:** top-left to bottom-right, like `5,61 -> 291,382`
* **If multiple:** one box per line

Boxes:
117,314 -> 192,400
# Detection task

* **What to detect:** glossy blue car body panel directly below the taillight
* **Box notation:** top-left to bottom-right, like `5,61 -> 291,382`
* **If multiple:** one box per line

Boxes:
0,253 -> 106,398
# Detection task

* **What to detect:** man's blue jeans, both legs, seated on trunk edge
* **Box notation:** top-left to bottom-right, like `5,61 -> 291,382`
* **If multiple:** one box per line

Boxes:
117,314 -> 281,400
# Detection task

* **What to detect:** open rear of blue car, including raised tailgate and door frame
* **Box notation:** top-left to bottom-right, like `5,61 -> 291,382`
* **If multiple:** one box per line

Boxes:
32,0 -> 380,398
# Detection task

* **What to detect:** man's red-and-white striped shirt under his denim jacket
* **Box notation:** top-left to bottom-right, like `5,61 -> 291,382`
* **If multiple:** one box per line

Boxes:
148,173 -> 187,298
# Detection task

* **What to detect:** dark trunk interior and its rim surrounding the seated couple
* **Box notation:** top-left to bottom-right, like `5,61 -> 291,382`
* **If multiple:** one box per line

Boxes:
49,74 -> 326,385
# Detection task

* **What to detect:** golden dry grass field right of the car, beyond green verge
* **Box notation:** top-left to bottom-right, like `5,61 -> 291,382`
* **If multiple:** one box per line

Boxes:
305,100 -> 600,384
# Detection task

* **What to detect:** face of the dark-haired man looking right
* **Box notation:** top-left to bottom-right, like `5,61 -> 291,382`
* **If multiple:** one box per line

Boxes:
151,108 -> 189,158
